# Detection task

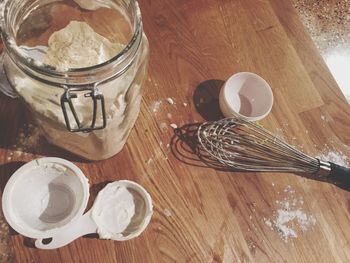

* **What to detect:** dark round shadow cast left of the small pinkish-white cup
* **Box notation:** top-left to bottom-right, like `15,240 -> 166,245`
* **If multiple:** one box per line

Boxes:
193,79 -> 225,121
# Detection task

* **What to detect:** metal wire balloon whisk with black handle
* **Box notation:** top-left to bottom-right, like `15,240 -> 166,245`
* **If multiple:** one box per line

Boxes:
197,118 -> 350,185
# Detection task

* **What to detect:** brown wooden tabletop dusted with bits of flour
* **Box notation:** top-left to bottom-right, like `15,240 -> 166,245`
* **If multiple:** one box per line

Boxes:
0,0 -> 350,263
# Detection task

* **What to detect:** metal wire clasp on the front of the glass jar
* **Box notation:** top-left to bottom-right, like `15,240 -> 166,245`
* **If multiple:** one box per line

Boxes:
61,85 -> 107,133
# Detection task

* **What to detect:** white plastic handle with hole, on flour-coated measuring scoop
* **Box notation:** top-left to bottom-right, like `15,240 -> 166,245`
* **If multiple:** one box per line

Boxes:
35,211 -> 97,249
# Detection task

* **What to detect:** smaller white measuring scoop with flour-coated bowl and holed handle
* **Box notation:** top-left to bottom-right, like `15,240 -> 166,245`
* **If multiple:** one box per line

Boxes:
35,180 -> 153,249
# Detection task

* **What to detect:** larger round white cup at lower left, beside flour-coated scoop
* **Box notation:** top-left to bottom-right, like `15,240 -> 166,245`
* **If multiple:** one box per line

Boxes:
2,158 -> 89,238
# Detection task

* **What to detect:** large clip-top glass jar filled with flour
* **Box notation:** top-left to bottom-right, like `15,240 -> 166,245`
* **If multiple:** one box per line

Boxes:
2,0 -> 149,160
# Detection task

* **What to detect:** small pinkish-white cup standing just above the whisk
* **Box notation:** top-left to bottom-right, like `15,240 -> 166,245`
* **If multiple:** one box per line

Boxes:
219,72 -> 273,121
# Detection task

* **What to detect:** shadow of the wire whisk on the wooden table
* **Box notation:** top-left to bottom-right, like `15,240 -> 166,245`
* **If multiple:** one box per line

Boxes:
171,123 -> 350,192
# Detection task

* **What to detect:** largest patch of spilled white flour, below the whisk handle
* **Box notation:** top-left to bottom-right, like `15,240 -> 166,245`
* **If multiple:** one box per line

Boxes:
264,186 -> 316,242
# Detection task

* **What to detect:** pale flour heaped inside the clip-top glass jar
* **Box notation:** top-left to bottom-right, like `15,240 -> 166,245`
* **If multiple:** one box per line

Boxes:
7,21 -> 148,160
